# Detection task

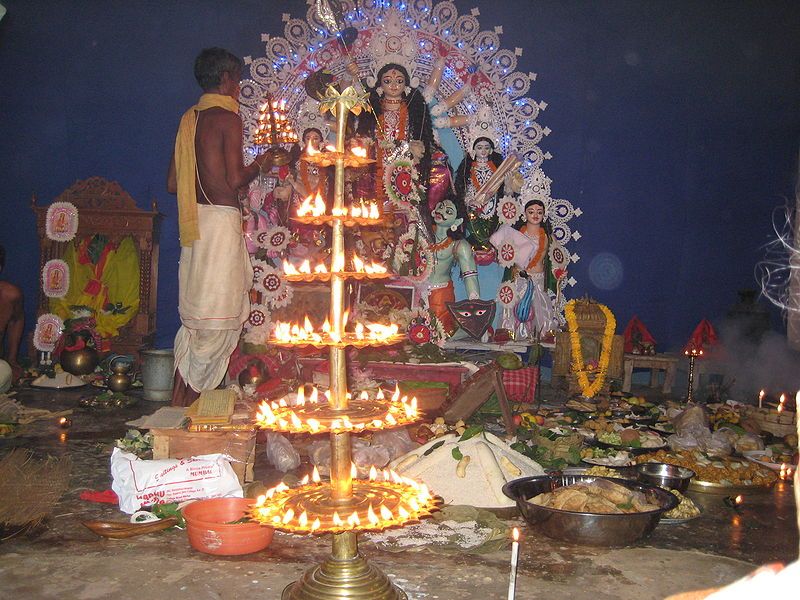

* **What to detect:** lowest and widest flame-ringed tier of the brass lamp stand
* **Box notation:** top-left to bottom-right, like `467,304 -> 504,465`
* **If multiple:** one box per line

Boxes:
250,474 -> 442,535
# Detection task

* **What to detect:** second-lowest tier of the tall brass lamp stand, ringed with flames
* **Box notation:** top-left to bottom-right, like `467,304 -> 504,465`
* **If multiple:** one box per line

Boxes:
256,398 -> 420,433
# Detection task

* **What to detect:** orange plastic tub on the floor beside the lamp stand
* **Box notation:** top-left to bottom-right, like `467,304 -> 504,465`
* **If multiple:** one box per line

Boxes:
181,498 -> 274,556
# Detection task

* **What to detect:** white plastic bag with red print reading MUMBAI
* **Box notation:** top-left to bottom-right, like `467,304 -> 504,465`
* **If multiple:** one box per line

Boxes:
111,448 -> 242,514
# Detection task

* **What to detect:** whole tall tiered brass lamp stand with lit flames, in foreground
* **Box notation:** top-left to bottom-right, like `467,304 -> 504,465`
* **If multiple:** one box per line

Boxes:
252,88 -> 441,600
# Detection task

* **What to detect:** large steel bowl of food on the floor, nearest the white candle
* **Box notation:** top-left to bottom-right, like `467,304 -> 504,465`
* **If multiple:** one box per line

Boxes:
503,475 -> 678,547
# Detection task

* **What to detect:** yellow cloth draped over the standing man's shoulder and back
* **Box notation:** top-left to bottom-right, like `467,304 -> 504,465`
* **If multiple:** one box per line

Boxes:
175,94 -> 239,246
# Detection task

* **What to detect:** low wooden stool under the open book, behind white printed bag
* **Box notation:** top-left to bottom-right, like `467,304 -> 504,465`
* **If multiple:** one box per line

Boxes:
150,429 -> 256,485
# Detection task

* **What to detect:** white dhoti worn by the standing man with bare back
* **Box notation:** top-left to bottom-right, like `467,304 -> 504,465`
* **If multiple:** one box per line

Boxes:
175,204 -> 253,392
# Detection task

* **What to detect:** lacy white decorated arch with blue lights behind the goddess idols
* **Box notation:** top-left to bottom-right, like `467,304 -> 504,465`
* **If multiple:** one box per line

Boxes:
240,0 -> 581,342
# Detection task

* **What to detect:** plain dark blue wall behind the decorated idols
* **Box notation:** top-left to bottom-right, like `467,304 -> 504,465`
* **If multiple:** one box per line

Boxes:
0,0 -> 800,349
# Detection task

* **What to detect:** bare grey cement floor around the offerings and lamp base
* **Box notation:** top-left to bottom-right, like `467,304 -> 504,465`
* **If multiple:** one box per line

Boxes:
0,389 -> 798,600
